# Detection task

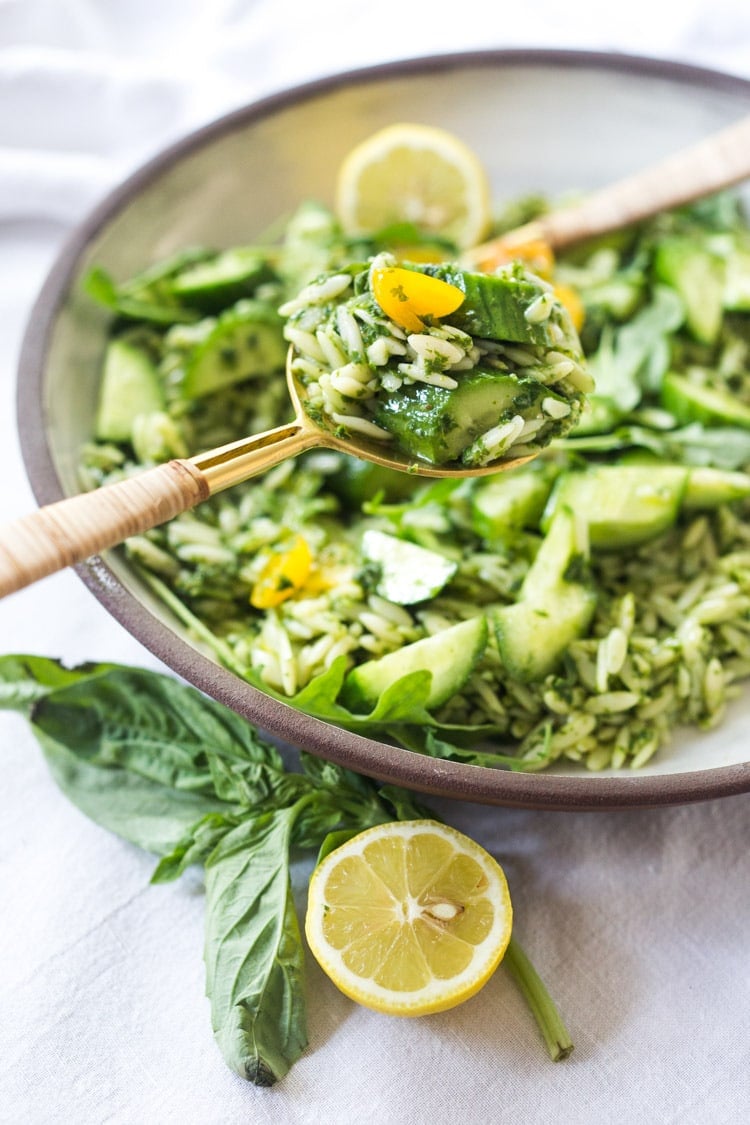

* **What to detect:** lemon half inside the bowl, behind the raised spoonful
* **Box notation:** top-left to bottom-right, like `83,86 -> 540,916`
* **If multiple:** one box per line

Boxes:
336,123 -> 491,249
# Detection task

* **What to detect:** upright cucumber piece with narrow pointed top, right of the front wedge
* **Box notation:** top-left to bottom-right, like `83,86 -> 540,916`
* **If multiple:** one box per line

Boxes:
493,507 -> 596,683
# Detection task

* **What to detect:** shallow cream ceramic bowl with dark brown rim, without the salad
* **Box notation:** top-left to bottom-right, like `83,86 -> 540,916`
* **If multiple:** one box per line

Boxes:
18,51 -> 750,809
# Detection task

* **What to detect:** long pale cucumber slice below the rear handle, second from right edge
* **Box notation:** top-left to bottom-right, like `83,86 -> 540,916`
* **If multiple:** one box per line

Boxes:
653,235 -> 725,344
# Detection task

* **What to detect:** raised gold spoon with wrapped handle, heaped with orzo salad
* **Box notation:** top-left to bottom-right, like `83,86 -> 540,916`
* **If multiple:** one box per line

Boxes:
0,254 -> 593,596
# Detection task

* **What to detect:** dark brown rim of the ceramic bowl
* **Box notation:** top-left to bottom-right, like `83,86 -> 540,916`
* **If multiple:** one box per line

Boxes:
17,47 -> 750,811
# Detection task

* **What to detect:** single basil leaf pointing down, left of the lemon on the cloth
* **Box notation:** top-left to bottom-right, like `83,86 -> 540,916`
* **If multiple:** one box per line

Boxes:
205,799 -> 307,1086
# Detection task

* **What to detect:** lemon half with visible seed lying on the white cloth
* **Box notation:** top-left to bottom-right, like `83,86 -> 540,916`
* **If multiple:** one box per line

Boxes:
305,820 -> 513,1016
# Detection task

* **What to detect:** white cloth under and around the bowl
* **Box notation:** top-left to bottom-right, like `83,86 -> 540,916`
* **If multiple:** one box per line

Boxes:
0,0 -> 750,1125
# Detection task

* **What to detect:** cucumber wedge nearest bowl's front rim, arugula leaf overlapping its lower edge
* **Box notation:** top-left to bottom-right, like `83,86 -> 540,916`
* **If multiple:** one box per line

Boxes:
342,614 -> 487,712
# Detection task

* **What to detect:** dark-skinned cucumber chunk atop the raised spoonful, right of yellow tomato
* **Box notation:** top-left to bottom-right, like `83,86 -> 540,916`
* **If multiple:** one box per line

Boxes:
420,262 -> 579,352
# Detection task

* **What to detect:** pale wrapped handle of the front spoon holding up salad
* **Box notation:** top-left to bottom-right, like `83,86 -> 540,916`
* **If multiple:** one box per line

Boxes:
0,460 -> 209,597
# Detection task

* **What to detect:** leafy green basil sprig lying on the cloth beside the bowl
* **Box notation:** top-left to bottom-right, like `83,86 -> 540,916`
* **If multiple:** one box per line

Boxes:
0,656 -> 432,1086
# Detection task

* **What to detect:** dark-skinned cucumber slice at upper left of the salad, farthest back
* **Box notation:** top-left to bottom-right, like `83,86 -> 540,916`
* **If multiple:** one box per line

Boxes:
171,246 -> 273,312
